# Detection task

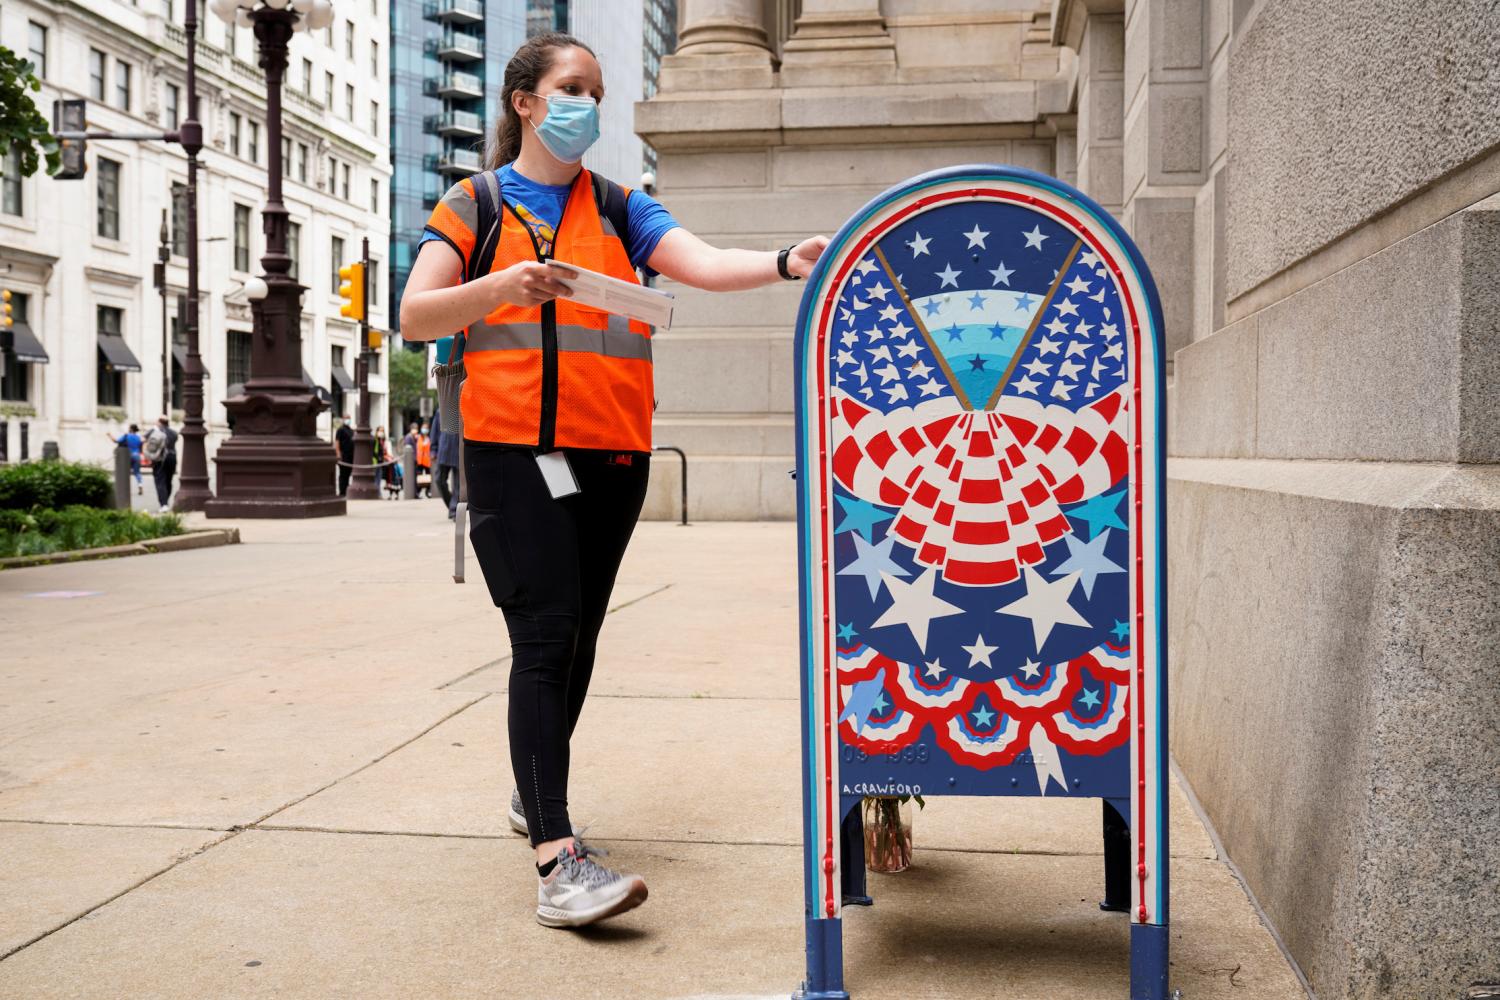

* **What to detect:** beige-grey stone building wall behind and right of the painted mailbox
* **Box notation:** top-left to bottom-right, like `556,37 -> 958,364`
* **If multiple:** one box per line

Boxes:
636,0 -> 1500,1000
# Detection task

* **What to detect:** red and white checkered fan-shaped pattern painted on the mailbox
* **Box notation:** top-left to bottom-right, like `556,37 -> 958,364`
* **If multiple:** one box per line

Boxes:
833,388 -> 1127,586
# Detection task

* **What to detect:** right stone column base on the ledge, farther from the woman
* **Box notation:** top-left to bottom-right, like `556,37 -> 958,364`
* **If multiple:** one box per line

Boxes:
782,0 -> 896,87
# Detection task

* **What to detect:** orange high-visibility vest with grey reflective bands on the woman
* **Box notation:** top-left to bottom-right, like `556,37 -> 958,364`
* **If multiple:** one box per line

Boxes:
444,169 -> 654,451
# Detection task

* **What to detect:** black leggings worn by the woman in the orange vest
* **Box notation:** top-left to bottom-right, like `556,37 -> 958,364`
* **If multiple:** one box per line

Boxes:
464,441 -> 651,844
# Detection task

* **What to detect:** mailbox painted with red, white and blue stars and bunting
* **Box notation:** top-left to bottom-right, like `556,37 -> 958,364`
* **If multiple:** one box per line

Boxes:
795,165 -> 1169,1000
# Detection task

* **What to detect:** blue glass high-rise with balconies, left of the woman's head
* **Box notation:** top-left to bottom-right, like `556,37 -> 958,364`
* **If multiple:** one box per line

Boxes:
390,0 -> 527,316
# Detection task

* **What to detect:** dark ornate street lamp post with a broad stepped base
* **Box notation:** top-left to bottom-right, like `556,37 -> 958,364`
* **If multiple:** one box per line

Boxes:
199,0 -> 345,517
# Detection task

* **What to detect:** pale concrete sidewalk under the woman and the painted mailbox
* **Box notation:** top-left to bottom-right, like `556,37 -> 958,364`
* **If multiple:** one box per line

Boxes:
0,502 -> 1305,1000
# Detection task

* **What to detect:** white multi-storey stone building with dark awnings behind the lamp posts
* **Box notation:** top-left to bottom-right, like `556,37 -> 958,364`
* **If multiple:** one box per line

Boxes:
0,0 -> 392,475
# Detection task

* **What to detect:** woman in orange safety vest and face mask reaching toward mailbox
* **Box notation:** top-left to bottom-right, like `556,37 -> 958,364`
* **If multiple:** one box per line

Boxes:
401,33 -> 828,927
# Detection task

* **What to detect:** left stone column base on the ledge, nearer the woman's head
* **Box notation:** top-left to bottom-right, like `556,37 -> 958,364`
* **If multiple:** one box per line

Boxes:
660,0 -> 776,91
